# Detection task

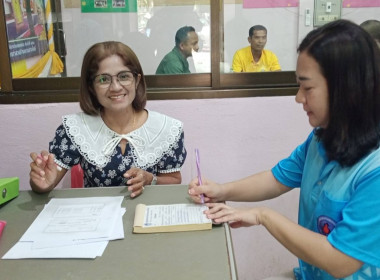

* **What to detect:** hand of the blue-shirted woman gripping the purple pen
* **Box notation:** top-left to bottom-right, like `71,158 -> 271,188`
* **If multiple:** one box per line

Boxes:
188,178 -> 224,203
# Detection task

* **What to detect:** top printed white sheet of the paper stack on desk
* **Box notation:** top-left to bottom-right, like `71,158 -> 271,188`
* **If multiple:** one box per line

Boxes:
20,196 -> 124,248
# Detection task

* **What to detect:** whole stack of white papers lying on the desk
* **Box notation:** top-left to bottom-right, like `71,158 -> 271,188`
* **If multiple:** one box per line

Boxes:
3,196 -> 125,259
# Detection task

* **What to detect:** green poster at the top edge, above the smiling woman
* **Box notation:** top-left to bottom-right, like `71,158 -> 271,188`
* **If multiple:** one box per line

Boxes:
81,0 -> 137,13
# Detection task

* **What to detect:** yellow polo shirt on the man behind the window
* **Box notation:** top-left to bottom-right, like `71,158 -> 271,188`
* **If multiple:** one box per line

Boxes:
232,46 -> 281,72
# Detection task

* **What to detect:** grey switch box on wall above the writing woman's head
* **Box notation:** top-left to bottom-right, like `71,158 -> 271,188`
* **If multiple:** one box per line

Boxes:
314,0 -> 342,26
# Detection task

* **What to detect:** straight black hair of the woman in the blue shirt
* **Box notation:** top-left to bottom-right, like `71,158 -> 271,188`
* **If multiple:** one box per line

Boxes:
298,20 -> 380,166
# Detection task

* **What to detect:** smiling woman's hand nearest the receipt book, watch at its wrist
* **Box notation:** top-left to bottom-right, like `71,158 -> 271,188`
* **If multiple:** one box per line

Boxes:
123,167 -> 153,197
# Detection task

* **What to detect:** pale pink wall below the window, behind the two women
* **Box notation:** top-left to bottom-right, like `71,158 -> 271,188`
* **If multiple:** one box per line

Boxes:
0,97 -> 311,279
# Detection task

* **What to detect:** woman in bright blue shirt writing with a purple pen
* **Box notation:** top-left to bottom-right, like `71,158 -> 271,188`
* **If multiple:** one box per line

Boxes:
189,20 -> 380,280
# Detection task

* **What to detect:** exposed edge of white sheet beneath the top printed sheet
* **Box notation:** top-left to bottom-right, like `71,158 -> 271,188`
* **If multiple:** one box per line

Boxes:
2,208 -> 126,259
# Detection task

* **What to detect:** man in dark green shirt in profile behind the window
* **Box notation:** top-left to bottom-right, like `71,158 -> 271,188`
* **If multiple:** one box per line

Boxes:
156,26 -> 199,74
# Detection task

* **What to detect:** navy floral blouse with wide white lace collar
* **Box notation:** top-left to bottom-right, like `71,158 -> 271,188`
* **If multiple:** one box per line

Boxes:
49,111 -> 186,188
